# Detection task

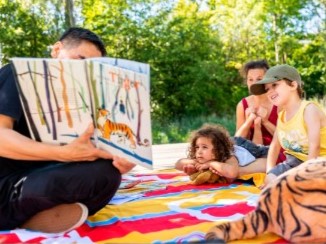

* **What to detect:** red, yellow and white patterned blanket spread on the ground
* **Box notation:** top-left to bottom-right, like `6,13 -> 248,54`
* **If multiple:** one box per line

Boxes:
0,170 -> 282,243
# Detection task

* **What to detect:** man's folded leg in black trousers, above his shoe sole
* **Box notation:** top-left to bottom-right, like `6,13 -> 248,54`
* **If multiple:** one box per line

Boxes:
0,160 -> 121,229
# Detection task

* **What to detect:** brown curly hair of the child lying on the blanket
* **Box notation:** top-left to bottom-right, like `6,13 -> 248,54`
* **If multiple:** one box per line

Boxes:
188,124 -> 234,162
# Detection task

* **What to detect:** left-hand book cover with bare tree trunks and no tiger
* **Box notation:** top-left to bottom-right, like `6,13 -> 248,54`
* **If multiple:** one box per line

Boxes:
12,58 -> 93,145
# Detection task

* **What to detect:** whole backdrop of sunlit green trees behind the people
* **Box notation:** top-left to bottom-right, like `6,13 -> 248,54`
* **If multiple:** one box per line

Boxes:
0,0 -> 326,142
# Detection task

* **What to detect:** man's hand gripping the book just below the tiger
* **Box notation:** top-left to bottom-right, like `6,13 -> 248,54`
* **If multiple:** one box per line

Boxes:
60,124 -> 113,162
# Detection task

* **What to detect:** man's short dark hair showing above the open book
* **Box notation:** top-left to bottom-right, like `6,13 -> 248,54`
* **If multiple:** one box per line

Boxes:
59,27 -> 106,56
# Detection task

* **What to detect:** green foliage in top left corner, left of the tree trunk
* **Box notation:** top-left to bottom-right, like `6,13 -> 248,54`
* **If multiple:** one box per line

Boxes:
0,0 -> 73,63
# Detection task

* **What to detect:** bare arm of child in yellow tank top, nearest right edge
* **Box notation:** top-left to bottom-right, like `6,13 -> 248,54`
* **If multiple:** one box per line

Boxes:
303,104 -> 323,160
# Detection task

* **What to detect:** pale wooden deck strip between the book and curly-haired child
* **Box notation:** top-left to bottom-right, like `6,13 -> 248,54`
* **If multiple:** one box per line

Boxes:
130,143 -> 189,173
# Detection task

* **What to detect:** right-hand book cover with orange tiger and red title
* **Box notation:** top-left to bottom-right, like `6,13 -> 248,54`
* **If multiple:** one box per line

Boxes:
87,58 -> 153,169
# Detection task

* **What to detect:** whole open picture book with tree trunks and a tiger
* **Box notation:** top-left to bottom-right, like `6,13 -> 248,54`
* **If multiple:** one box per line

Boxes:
11,58 -> 153,168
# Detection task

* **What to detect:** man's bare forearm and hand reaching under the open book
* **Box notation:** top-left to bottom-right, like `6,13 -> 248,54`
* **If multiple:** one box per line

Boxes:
0,114 -> 112,162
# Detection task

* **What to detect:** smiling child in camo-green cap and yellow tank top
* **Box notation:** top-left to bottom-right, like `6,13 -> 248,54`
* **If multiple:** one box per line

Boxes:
250,64 -> 326,186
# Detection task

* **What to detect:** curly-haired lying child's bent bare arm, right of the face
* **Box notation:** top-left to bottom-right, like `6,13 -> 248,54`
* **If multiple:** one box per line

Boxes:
209,156 -> 239,181
